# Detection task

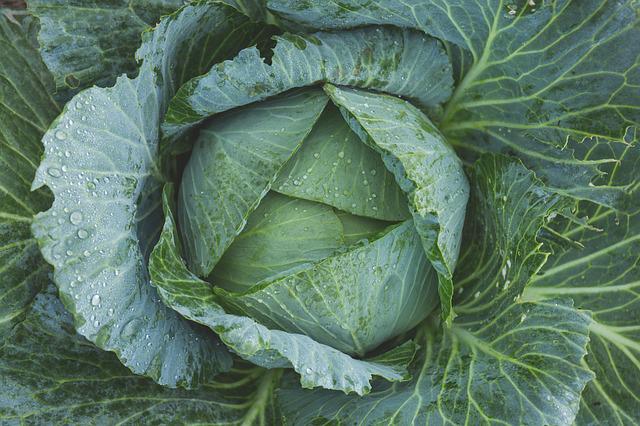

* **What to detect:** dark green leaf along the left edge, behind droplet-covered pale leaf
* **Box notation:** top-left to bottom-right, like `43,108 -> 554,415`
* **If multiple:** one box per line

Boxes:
0,14 -> 59,341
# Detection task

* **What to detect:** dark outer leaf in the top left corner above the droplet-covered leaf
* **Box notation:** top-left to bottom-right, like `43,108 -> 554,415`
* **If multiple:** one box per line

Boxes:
28,0 -> 184,95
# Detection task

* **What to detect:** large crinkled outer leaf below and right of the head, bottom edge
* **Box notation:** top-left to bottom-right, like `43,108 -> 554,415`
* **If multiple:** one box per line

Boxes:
279,156 -> 592,425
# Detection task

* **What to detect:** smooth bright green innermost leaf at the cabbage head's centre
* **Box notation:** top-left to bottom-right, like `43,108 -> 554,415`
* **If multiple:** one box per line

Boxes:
209,192 -> 345,292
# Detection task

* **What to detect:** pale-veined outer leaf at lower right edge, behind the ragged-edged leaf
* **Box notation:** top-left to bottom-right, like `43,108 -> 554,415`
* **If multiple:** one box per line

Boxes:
524,138 -> 640,425
